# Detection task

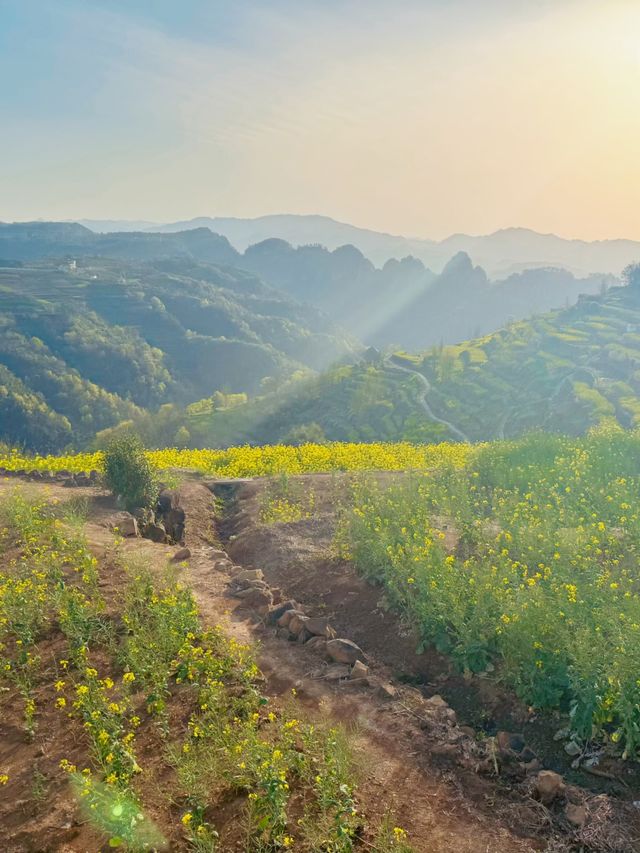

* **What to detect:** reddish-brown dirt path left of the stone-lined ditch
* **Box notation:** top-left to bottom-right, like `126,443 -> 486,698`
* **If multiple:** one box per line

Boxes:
169,484 -> 539,853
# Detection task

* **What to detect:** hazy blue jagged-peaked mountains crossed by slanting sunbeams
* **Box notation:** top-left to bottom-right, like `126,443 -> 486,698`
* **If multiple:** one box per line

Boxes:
240,245 -> 617,350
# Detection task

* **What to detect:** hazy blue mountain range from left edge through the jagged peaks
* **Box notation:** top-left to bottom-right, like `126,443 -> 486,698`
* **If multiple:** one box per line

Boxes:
0,222 -> 615,350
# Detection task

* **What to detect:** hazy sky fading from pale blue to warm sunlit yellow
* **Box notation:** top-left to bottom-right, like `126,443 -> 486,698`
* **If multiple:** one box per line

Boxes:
0,0 -> 640,239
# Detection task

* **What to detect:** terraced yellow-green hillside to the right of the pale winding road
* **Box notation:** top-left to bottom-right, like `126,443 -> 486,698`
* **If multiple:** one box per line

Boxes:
394,267 -> 640,440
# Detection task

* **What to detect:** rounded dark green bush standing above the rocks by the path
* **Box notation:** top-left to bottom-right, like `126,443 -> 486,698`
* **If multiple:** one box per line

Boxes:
104,435 -> 158,512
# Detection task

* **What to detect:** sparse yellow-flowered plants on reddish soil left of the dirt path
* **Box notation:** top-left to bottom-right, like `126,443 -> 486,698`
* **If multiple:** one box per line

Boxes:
0,492 -> 411,853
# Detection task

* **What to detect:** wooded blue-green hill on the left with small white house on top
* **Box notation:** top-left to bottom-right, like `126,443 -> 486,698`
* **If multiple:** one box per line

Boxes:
0,258 -> 353,451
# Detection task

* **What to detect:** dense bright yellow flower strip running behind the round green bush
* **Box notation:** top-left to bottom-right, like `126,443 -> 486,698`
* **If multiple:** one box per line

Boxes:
0,442 -> 469,477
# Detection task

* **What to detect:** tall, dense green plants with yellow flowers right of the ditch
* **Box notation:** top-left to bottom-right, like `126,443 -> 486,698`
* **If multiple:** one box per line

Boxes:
340,429 -> 640,757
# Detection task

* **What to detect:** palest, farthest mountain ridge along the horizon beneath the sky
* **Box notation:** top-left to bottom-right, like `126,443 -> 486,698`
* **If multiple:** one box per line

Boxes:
80,214 -> 640,278
